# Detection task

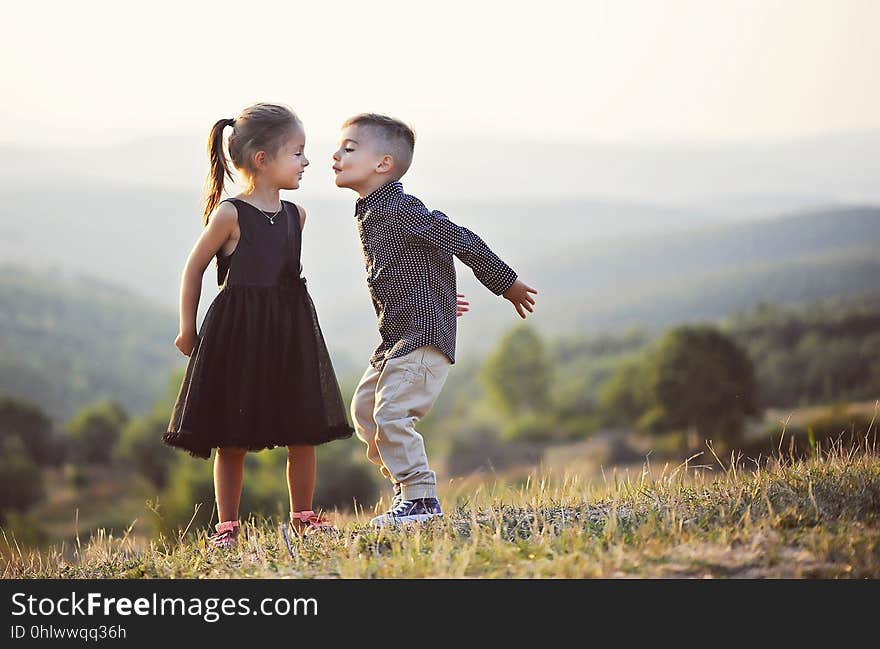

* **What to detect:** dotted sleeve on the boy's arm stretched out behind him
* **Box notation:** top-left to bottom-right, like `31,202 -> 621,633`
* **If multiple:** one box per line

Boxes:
399,197 -> 517,295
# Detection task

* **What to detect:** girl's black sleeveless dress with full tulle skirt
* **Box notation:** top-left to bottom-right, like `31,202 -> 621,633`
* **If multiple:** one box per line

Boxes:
162,198 -> 354,458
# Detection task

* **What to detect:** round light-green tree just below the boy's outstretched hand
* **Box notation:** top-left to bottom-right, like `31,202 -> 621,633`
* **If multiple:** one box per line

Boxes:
480,325 -> 550,414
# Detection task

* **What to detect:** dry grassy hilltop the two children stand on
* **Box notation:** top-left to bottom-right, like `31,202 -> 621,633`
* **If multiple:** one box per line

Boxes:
3,438 -> 880,579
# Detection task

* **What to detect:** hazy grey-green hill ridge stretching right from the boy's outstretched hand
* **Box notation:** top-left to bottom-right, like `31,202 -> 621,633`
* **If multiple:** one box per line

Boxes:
461,207 -> 880,347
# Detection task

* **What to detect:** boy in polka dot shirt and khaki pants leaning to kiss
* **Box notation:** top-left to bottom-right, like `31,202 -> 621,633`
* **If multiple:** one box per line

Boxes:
333,113 -> 537,527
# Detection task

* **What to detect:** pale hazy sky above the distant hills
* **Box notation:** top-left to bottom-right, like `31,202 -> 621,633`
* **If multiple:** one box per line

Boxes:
0,0 -> 880,145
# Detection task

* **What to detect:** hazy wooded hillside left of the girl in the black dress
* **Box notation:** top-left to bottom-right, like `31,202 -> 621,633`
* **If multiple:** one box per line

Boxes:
0,266 -> 182,420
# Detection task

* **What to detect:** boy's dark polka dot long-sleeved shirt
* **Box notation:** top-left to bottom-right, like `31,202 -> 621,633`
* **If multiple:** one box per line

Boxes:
355,182 -> 516,370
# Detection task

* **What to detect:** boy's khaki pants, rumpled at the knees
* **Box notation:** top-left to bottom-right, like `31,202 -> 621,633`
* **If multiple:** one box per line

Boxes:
351,346 -> 451,500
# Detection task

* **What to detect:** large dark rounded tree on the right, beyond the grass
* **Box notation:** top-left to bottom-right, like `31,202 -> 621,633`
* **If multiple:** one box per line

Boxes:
641,326 -> 758,445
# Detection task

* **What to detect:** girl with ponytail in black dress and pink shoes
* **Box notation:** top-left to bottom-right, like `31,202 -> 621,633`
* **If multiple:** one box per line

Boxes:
162,104 -> 354,547
